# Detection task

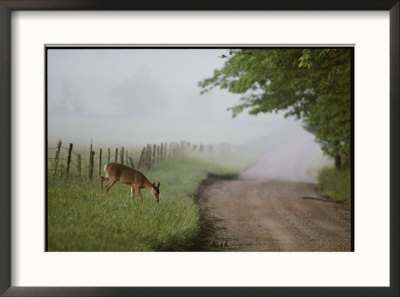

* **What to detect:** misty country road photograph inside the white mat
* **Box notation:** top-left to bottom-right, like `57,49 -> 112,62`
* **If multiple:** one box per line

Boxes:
46,46 -> 354,252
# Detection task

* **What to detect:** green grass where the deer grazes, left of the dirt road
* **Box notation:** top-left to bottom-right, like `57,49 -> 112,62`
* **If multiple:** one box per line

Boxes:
48,156 -> 243,251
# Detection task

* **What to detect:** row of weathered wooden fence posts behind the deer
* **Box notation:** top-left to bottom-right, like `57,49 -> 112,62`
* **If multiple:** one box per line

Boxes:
47,139 -> 213,180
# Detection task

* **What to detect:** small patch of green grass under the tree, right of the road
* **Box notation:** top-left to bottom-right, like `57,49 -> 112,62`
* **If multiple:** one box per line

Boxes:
318,167 -> 351,204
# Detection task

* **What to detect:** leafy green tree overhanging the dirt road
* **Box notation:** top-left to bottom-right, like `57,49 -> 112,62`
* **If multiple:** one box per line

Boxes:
199,48 -> 352,168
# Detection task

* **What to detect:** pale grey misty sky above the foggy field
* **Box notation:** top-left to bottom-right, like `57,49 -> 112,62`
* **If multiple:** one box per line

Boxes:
48,49 -> 311,146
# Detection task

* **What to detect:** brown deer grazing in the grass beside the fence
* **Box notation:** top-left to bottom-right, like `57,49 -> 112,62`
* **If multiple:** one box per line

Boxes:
100,163 -> 160,203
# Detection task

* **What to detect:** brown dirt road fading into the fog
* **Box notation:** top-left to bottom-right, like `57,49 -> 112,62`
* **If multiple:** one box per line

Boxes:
197,136 -> 351,251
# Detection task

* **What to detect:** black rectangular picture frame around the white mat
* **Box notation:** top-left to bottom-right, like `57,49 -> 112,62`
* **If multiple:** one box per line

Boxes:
0,0 -> 400,296
